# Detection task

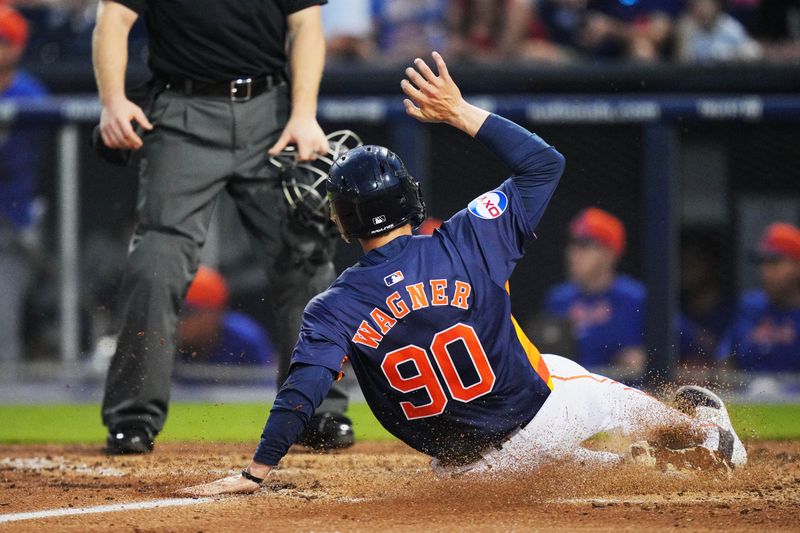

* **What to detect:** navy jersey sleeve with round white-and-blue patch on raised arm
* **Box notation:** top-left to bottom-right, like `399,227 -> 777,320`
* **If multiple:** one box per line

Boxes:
440,179 -> 534,285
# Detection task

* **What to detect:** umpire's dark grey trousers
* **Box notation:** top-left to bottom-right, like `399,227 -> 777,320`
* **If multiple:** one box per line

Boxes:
103,84 -> 347,433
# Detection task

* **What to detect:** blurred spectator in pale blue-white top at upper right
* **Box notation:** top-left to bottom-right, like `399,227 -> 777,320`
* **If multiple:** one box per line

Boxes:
677,0 -> 761,62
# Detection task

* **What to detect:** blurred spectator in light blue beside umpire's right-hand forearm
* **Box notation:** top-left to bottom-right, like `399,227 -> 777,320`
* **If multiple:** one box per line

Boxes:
322,0 -> 374,60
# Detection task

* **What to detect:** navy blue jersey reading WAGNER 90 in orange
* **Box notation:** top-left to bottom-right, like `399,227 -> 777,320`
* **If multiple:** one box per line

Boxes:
292,180 -> 549,459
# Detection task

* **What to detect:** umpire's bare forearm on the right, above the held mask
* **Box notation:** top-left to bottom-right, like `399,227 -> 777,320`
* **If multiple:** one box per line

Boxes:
289,6 -> 325,118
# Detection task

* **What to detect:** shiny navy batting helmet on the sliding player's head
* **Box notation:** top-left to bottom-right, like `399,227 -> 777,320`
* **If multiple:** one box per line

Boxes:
327,146 -> 425,239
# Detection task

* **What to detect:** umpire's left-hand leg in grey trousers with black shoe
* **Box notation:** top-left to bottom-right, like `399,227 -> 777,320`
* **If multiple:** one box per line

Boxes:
103,92 -> 231,453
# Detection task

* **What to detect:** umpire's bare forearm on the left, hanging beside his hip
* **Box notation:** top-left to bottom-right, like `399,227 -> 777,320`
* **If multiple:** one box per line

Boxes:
92,0 -> 137,104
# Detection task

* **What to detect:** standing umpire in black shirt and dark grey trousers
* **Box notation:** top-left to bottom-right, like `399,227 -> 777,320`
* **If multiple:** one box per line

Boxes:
93,0 -> 353,454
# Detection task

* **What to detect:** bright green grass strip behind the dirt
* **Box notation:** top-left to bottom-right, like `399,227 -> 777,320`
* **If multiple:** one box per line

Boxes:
0,404 -> 800,443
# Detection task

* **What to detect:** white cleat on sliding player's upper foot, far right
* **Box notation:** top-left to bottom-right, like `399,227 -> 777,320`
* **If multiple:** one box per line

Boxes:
675,385 -> 747,468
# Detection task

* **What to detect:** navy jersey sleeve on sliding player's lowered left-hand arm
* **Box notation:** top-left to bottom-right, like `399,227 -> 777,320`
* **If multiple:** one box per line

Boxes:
291,296 -> 349,372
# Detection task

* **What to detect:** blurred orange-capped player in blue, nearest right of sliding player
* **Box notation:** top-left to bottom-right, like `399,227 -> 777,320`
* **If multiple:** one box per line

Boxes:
545,208 -> 646,374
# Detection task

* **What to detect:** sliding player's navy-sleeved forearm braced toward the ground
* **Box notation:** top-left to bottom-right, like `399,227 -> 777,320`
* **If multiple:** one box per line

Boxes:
253,365 -> 333,466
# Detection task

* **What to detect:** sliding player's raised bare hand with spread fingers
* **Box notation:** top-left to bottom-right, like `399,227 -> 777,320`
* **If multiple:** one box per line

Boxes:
400,52 -> 489,137
